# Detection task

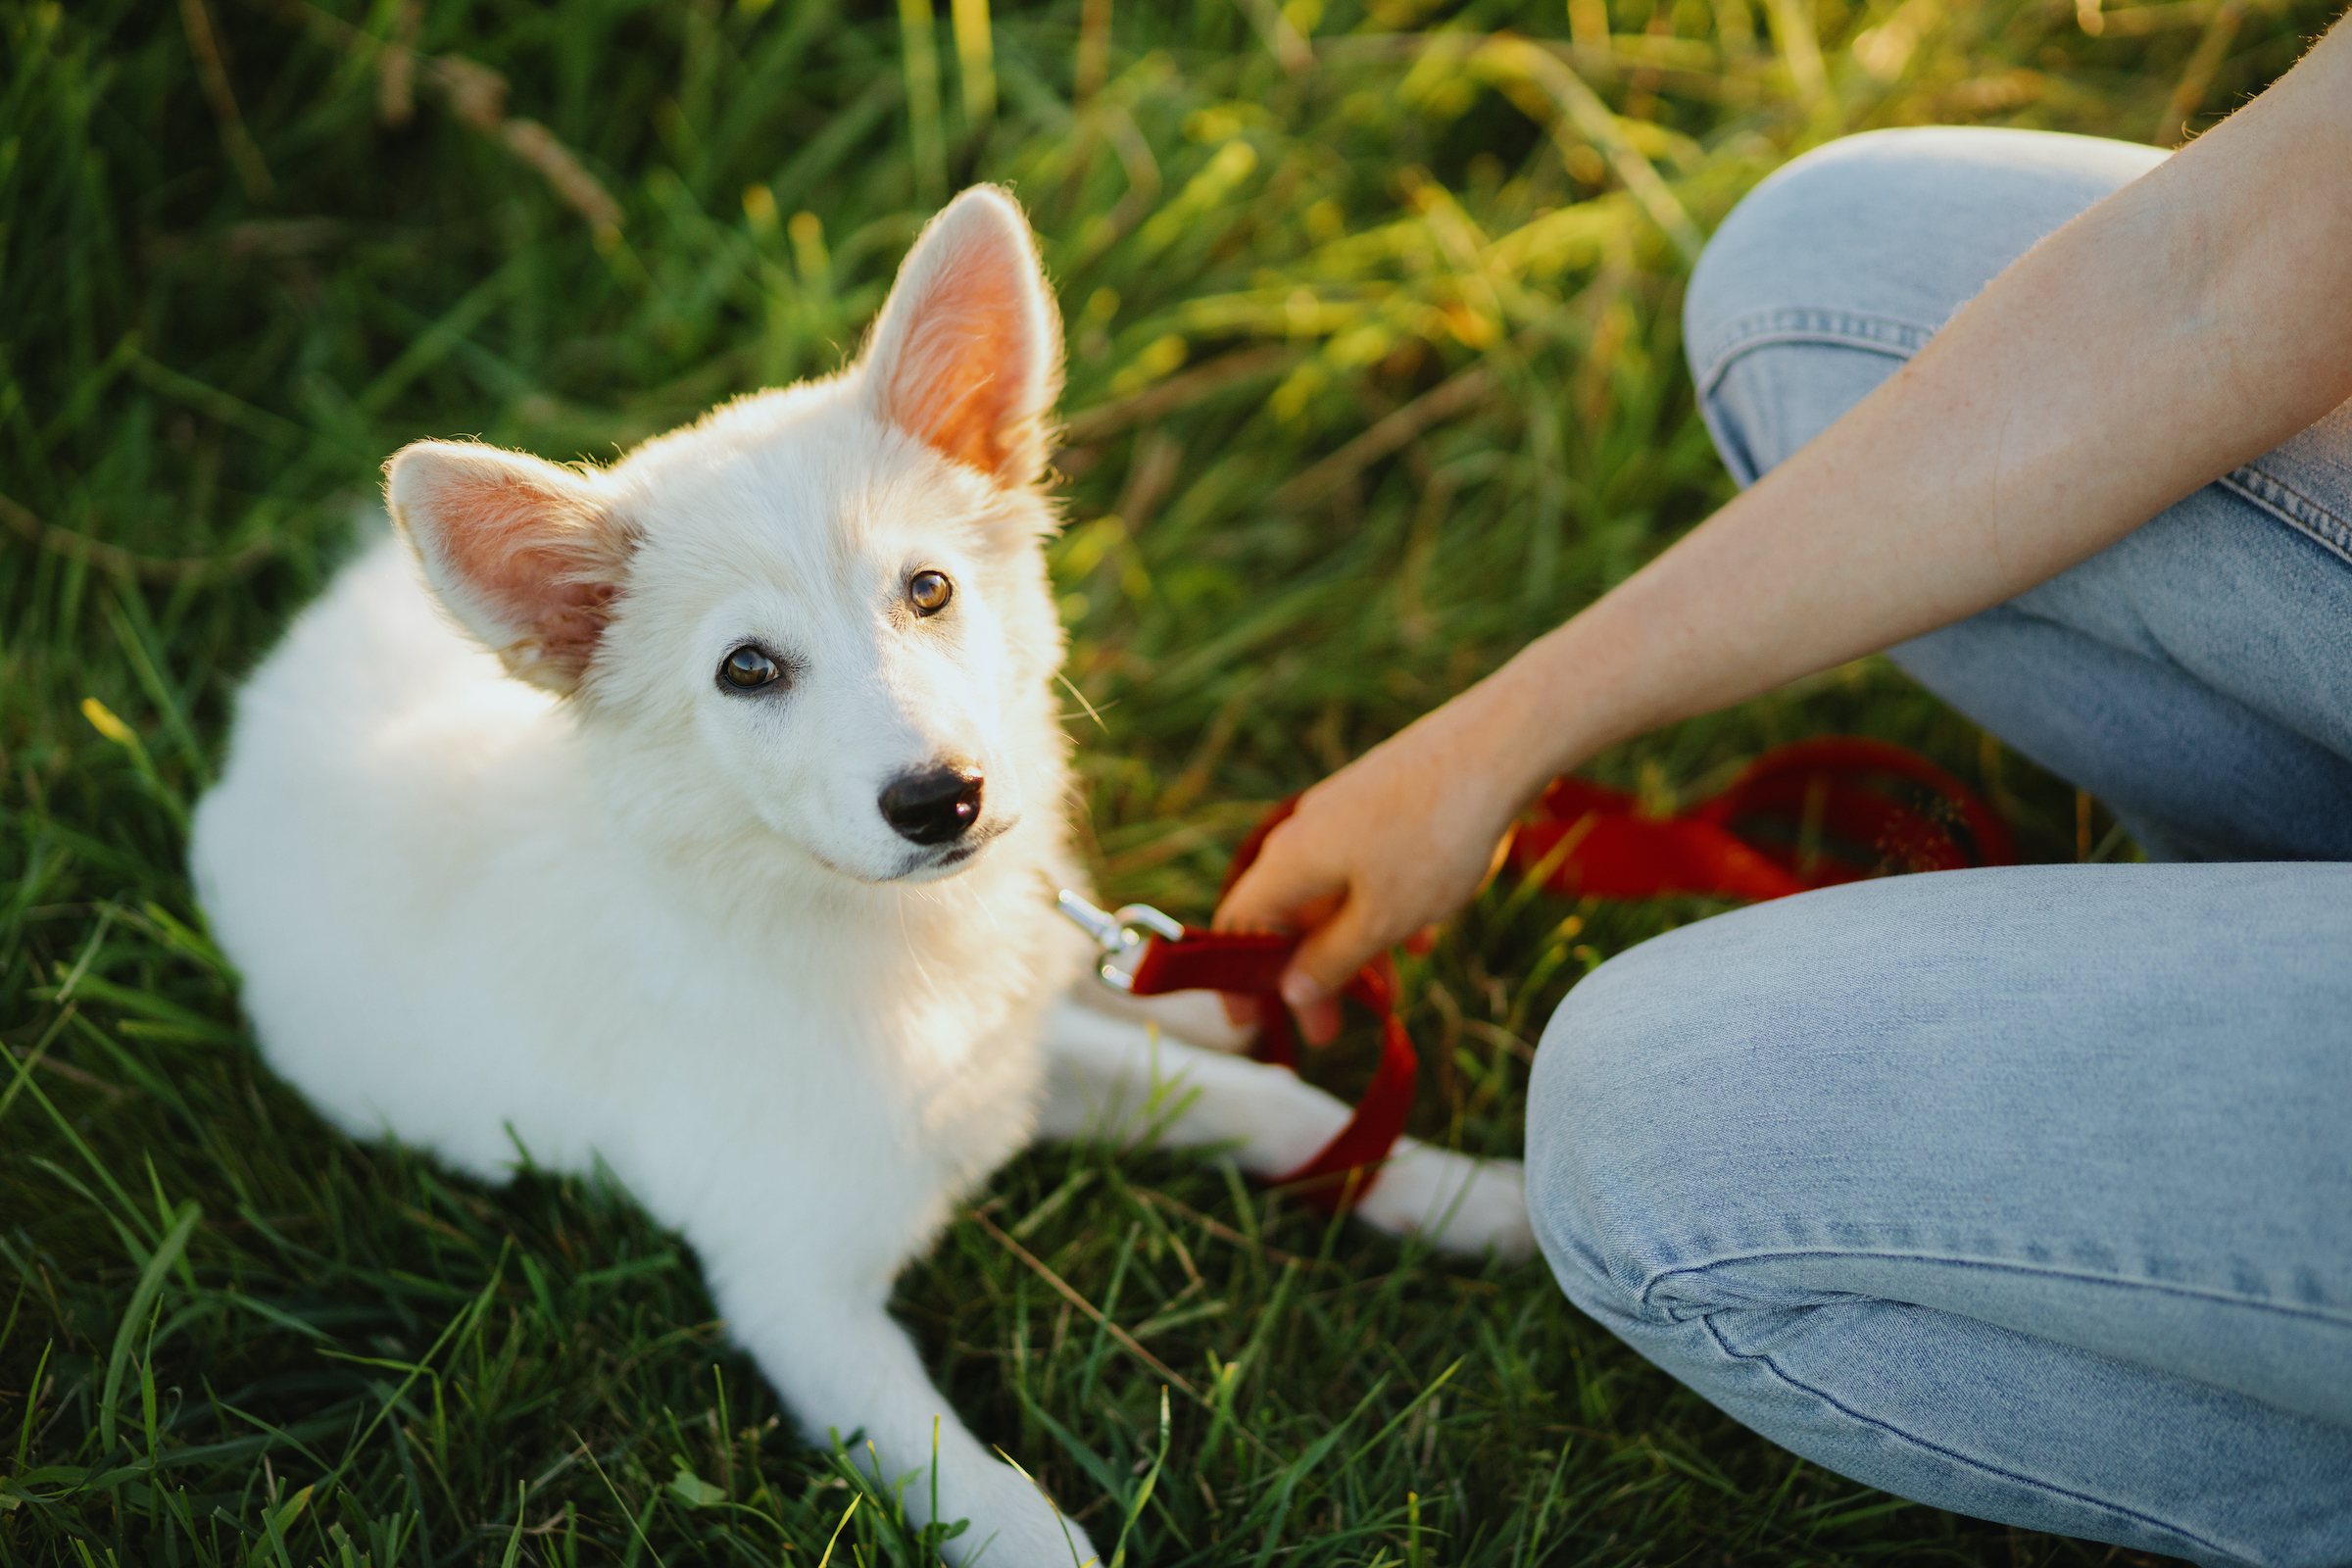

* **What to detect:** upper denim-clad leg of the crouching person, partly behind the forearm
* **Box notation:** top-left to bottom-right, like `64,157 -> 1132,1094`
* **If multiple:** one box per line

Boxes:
1684,129 -> 2352,858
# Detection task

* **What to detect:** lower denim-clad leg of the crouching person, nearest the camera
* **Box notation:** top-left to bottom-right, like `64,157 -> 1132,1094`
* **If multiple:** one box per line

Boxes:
1527,865 -> 2352,1566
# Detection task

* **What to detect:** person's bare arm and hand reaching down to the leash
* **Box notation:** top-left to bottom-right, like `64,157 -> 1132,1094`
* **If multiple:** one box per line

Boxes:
1216,24 -> 2352,1039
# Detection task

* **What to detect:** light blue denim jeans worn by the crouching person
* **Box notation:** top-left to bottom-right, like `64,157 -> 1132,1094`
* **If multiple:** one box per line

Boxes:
1527,129 -> 2352,1566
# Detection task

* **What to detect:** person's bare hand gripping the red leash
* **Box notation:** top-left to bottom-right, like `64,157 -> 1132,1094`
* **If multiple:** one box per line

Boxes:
1216,703 -> 1519,1044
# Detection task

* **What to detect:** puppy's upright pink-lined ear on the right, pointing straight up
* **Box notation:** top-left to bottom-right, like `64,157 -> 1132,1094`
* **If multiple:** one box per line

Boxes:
863,186 -> 1060,487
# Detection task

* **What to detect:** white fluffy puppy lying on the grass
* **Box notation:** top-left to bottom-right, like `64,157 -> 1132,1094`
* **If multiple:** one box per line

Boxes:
190,188 -> 1529,1566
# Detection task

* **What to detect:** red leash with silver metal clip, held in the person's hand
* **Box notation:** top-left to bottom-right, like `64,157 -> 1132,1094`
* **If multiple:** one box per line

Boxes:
1060,738 -> 2009,1213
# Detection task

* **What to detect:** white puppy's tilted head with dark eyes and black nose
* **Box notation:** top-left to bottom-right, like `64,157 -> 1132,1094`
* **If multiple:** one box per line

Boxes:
386,188 -> 1063,882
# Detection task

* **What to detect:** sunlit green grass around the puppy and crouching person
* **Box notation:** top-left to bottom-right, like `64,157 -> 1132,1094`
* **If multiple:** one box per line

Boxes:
0,0 -> 2327,1568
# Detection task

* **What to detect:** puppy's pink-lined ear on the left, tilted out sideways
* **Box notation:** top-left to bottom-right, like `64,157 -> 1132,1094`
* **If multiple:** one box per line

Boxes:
383,442 -> 633,696
